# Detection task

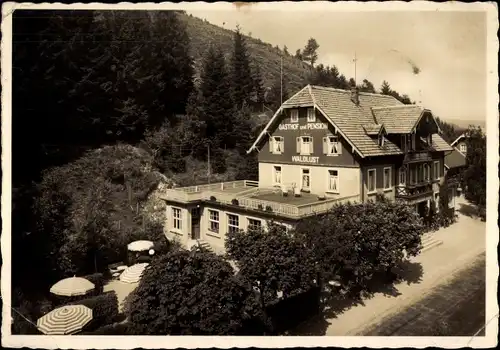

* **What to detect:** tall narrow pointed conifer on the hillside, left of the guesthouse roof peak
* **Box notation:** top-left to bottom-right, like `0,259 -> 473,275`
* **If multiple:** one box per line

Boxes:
231,27 -> 254,108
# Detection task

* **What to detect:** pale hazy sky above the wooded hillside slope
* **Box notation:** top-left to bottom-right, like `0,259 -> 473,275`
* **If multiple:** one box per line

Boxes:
187,5 -> 487,122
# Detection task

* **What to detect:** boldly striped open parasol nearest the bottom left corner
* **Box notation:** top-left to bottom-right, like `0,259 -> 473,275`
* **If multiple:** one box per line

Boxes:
37,305 -> 92,335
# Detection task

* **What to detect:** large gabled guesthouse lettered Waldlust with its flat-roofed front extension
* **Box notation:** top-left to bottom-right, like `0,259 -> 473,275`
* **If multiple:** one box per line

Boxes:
164,85 -> 453,252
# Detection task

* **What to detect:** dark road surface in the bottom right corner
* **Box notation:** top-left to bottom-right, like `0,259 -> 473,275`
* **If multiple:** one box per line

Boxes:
357,254 -> 486,336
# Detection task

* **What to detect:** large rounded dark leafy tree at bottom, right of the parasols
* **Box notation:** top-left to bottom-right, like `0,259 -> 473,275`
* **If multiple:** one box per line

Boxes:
127,250 -> 258,335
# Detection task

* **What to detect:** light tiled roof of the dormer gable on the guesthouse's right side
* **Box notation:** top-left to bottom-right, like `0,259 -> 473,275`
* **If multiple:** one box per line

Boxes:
372,105 -> 424,134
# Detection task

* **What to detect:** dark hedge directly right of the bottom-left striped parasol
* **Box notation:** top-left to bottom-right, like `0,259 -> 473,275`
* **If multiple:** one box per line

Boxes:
71,291 -> 118,330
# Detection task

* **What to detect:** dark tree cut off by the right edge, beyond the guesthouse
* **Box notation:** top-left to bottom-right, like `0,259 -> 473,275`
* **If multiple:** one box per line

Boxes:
463,126 -> 486,218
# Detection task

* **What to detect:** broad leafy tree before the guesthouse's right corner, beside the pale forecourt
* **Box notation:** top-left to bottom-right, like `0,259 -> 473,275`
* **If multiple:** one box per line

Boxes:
295,200 -> 424,293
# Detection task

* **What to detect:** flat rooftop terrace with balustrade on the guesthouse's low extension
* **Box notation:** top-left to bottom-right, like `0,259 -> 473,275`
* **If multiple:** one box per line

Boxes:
162,180 -> 360,219
